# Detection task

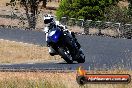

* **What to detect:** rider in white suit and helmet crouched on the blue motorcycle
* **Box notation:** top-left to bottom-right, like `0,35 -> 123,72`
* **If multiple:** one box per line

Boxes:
44,14 -> 80,56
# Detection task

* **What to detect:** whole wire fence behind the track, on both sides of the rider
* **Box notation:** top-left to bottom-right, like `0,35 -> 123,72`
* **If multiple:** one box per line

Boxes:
0,10 -> 132,38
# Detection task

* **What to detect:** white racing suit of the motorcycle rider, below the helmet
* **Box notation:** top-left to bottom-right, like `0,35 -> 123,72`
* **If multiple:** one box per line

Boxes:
44,21 -> 80,56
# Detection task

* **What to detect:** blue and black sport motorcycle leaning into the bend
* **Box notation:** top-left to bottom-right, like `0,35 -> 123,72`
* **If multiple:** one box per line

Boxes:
48,27 -> 85,64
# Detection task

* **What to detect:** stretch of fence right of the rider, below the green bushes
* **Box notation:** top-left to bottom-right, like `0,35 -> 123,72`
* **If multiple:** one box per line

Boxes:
60,17 -> 132,38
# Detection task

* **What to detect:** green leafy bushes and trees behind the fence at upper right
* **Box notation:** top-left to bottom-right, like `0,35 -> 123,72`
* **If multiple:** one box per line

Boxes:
56,0 -> 132,23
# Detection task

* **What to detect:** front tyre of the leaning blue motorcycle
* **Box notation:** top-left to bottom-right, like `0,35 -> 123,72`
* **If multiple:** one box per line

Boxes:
58,47 -> 73,64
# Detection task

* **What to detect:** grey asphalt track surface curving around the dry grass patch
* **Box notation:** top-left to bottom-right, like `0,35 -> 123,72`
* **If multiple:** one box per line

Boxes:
0,28 -> 132,70
